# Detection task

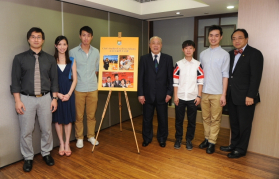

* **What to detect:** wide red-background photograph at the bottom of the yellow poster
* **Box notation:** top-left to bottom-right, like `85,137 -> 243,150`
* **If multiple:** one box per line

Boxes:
102,72 -> 134,88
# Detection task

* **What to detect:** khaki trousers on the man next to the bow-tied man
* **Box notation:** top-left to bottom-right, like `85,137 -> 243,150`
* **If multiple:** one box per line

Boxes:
201,93 -> 223,144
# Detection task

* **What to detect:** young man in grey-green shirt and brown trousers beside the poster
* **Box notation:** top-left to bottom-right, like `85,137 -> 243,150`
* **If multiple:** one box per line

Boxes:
70,26 -> 100,148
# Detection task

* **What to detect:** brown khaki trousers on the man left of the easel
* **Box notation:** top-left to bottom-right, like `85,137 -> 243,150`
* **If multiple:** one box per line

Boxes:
75,90 -> 98,139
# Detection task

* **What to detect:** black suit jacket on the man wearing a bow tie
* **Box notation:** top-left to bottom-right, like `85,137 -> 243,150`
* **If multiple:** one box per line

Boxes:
227,45 -> 263,105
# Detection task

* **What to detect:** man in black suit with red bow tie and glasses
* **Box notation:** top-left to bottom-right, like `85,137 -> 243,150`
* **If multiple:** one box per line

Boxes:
220,29 -> 263,158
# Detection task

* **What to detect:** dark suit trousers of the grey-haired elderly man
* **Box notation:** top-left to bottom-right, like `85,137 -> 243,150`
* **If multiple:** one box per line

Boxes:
142,101 -> 169,142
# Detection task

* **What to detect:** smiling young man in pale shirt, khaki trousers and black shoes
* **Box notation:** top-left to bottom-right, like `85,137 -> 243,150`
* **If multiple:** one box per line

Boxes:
199,25 -> 230,154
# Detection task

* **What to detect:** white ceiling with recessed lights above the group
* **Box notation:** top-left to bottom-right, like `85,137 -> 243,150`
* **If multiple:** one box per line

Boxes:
61,0 -> 239,21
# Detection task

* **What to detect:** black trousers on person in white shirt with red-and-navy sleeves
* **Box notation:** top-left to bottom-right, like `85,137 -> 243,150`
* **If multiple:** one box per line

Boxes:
175,99 -> 197,141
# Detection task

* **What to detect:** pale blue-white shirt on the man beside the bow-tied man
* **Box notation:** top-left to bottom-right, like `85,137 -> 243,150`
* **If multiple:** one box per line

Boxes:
200,46 -> 230,94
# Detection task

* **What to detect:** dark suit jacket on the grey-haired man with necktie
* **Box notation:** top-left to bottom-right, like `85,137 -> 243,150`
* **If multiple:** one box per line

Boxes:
138,53 -> 173,104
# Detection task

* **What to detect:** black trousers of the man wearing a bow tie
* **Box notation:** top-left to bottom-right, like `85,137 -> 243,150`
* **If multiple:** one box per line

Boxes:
228,95 -> 255,154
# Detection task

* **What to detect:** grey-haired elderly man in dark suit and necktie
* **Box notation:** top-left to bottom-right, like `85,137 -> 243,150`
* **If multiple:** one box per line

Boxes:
138,36 -> 173,147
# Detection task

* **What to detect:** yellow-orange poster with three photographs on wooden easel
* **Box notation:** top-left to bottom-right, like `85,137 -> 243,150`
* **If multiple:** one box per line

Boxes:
98,37 -> 139,91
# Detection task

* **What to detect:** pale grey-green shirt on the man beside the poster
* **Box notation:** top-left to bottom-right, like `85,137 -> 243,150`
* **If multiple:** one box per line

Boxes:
70,45 -> 100,92
